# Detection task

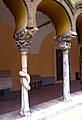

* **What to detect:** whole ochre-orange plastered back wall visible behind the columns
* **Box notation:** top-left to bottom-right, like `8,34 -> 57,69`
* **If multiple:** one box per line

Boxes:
0,24 -> 79,90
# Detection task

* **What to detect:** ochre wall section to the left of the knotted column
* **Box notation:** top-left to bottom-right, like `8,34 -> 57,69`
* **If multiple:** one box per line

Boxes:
0,24 -> 21,90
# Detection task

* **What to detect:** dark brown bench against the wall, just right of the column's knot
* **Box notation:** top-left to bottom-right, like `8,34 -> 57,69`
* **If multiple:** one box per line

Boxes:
30,75 -> 42,89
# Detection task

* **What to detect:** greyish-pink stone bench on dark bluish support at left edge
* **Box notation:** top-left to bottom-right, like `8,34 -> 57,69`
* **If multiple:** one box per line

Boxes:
0,70 -> 12,97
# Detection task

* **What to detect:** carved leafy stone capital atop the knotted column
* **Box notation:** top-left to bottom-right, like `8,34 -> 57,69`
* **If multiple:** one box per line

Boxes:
15,27 -> 38,52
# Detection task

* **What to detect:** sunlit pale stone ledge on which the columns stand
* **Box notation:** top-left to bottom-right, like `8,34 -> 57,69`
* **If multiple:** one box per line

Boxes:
0,91 -> 82,120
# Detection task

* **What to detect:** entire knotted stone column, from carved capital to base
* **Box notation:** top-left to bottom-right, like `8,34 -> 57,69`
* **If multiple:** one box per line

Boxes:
15,28 -> 38,116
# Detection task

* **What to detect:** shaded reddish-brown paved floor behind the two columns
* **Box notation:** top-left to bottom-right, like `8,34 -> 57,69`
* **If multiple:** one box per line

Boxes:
0,81 -> 81,114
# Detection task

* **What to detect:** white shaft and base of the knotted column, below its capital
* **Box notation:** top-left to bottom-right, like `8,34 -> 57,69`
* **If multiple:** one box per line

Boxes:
19,52 -> 30,116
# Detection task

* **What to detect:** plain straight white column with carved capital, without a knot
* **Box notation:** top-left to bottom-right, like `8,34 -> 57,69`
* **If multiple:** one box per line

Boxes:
57,36 -> 71,101
